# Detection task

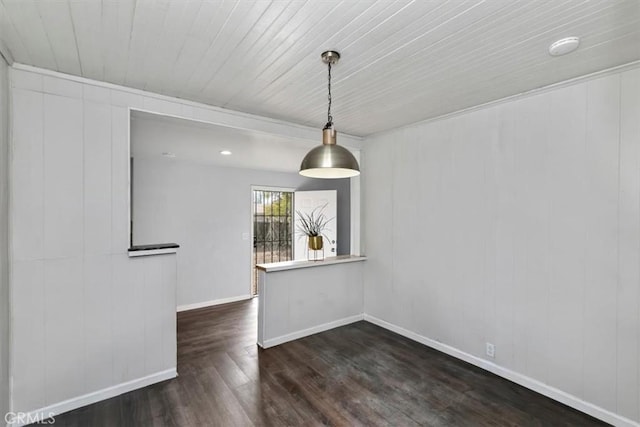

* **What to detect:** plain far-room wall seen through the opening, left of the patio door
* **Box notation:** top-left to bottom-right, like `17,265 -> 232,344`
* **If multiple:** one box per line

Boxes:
132,157 -> 305,306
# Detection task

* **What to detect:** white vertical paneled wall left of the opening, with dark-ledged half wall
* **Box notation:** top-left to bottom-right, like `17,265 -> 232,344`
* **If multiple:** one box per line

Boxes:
10,70 -> 177,411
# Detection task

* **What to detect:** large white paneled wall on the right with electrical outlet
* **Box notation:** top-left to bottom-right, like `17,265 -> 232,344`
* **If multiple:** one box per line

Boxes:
363,69 -> 640,424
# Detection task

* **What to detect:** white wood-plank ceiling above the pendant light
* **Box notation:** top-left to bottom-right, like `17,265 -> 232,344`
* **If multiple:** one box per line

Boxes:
0,0 -> 640,136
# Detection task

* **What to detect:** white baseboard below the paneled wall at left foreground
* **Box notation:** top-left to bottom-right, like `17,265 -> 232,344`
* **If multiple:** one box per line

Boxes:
7,368 -> 178,427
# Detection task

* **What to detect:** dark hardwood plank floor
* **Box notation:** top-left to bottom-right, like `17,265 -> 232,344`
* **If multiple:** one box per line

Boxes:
43,300 -> 605,427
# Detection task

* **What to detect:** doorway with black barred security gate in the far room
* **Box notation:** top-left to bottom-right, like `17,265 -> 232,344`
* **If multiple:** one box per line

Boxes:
251,188 -> 294,296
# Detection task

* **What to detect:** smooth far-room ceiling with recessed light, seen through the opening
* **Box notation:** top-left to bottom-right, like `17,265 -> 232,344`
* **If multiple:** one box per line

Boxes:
131,111 -> 319,172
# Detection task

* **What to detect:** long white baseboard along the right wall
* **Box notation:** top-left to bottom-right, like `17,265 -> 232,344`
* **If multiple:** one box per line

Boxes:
364,314 -> 640,427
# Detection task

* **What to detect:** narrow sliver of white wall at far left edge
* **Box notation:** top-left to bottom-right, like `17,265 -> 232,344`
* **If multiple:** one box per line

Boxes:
0,55 -> 10,422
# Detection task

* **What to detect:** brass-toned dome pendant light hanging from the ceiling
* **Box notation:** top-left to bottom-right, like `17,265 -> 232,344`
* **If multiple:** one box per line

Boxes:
300,50 -> 360,178
